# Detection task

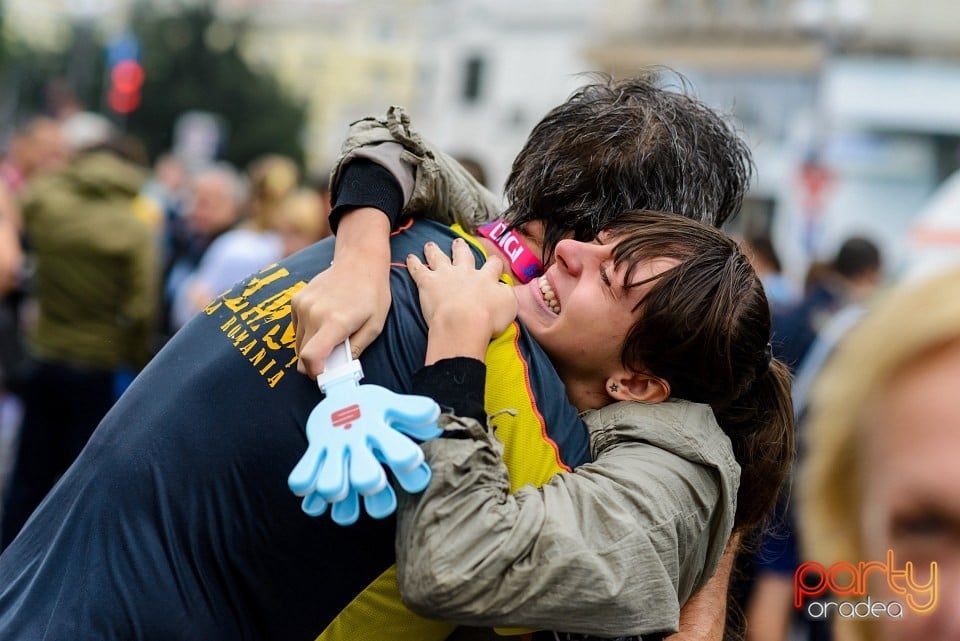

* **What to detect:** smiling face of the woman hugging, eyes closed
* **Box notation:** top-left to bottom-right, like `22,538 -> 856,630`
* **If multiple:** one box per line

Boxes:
516,239 -> 678,408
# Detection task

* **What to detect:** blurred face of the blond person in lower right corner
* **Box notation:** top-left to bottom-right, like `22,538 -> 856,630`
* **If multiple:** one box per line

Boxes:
860,340 -> 960,641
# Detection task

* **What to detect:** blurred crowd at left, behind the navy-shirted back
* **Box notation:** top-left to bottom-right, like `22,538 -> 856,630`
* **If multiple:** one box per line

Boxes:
0,112 -> 330,549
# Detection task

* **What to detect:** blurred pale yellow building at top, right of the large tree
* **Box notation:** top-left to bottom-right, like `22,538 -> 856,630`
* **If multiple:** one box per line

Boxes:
236,0 -> 426,169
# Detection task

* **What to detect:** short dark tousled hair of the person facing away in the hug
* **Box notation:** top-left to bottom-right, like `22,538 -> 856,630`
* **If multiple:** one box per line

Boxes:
505,67 -> 753,252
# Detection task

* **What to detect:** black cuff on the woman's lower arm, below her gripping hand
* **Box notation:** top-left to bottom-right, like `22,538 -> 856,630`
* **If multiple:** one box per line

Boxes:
411,356 -> 487,425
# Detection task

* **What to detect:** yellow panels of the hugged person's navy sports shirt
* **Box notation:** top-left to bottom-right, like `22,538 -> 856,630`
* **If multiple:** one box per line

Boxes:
316,225 -> 566,641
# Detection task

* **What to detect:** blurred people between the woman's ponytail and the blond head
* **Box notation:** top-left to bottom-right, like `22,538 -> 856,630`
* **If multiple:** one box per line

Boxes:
735,228 -> 884,641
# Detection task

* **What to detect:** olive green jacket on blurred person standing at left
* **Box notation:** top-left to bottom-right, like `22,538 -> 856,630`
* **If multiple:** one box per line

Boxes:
23,151 -> 160,369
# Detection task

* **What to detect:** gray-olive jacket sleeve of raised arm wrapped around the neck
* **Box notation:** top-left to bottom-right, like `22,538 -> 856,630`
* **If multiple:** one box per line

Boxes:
330,106 -> 503,233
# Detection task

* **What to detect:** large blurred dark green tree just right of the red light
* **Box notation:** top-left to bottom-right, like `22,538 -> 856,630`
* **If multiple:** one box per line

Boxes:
126,3 -> 306,167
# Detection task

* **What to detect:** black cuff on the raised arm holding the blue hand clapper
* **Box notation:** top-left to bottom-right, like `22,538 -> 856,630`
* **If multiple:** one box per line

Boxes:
330,158 -> 403,233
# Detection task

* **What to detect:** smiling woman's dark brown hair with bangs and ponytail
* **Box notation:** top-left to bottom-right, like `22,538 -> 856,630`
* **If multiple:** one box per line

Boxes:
608,211 -> 794,528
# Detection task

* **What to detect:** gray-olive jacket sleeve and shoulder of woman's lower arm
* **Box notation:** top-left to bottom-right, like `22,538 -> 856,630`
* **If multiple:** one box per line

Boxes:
397,403 -> 739,636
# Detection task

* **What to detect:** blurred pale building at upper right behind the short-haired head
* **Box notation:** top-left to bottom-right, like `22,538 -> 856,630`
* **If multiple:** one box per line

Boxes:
588,0 -> 960,280
